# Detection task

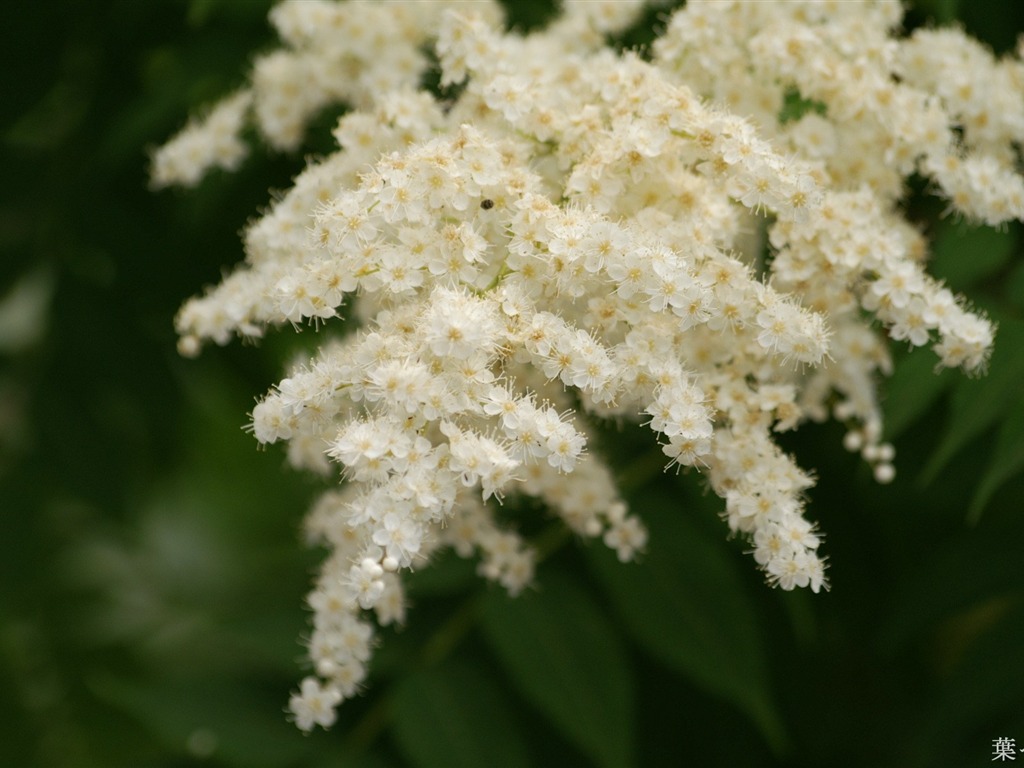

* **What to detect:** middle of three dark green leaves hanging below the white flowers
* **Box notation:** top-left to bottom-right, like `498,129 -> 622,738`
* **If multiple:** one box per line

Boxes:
481,571 -> 633,767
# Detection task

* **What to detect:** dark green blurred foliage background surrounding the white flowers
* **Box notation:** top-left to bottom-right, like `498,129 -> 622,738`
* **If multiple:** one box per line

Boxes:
0,0 -> 1024,768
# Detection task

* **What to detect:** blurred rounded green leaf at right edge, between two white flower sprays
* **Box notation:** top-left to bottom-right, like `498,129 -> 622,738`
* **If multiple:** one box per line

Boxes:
929,221 -> 1017,291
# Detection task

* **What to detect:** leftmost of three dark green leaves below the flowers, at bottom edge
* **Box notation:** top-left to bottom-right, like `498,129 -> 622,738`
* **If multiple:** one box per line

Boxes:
393,658 -> 530,768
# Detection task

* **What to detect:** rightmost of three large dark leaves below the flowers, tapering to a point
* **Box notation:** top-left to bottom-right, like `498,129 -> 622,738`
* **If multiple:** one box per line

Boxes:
591,489 -> 786,752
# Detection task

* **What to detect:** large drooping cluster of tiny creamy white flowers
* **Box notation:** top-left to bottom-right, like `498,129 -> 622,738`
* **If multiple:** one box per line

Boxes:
153,0 -> 1024,729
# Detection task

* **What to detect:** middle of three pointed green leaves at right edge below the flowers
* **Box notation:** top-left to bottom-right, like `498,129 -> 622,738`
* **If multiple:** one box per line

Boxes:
921,319 -> 1024,484
